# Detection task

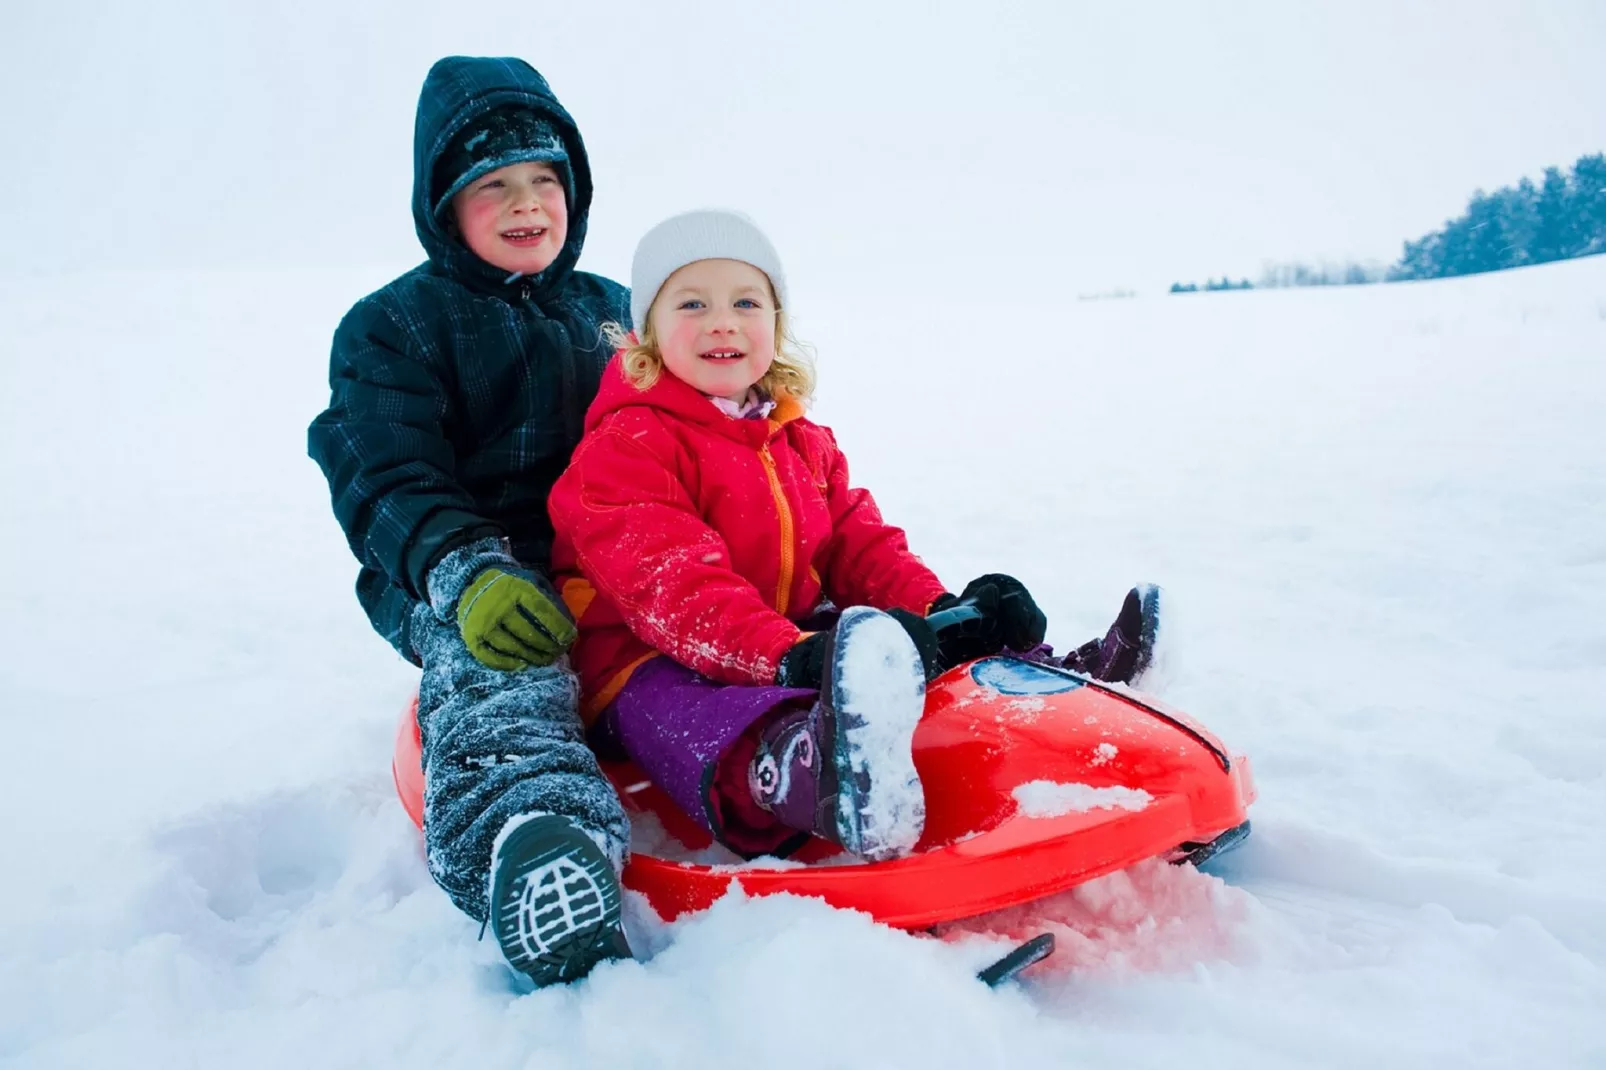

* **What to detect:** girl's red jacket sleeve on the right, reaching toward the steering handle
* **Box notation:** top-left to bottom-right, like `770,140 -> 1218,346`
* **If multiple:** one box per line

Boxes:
821,431 -> 944,615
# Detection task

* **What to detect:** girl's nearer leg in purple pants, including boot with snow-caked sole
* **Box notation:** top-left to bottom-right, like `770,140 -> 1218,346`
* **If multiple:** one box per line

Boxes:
593,606 -> 925,860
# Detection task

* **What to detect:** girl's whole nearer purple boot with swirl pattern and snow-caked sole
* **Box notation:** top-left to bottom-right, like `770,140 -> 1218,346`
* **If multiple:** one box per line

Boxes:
748,606 -> 925,861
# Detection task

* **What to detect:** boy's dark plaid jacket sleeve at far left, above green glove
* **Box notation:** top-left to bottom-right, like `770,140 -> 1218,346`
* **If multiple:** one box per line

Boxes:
307,299 -> 501,599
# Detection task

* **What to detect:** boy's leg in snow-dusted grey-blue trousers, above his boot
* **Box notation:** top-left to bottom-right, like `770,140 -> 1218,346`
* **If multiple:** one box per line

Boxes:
413,606 -> 630,922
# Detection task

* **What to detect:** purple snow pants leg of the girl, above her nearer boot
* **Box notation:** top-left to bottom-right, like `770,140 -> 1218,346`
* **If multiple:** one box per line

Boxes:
589,655 -> 819,855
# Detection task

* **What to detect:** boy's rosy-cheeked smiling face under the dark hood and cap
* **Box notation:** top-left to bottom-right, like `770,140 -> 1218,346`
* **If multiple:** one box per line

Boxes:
451,162 -> 569,275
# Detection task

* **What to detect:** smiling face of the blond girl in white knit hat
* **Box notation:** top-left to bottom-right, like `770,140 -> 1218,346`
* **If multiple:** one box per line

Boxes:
647,260 -> 776,402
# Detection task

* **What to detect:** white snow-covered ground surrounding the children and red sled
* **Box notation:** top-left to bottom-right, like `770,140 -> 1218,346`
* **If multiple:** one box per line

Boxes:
0,257 -> 1606,1070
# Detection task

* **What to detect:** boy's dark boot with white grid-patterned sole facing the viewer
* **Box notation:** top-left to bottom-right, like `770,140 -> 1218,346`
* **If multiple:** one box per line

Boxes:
488,815 -> 631,986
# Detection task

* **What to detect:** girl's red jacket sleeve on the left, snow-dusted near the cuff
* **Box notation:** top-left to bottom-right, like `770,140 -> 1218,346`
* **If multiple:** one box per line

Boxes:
548,419 -> 803,684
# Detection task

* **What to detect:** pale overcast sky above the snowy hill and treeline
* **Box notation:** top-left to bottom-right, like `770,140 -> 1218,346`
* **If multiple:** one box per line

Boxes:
0,0 -> 1606,297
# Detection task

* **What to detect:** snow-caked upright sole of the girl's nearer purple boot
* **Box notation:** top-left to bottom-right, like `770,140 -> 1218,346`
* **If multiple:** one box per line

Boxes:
829,606 -> 925,861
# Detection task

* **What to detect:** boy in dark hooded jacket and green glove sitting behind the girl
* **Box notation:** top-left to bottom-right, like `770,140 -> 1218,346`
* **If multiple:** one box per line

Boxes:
308,56 -> 630,985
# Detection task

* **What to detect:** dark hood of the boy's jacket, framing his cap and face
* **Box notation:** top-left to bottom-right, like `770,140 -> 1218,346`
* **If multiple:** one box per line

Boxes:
413,56 -> 591,297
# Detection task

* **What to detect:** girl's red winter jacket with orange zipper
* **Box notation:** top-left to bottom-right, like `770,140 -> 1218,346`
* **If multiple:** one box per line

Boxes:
548,358 -> 943,721
